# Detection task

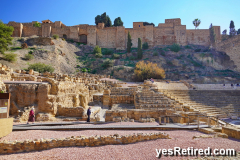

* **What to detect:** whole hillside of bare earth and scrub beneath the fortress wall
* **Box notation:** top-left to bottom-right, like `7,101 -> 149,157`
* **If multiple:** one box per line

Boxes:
3,37 -> 240,83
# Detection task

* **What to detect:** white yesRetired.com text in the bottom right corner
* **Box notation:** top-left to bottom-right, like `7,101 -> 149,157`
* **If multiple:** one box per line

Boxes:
156,147 -> 236,158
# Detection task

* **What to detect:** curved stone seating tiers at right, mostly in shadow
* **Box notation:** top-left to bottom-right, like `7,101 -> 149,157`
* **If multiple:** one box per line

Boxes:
163,90 -> 240,117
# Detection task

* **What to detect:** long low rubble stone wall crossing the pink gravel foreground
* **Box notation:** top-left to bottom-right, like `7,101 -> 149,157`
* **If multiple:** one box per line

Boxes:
0,132 -> 170,154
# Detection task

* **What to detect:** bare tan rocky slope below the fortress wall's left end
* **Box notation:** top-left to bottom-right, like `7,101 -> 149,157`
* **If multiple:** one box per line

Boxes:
0,37 -> 89,74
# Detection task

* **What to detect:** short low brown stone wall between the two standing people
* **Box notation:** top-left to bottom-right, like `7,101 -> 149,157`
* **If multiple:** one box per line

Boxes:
57,107 -> 84,117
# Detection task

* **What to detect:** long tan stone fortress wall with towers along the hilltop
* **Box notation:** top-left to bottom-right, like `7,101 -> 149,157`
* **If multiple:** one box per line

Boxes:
8,18 -> 221,49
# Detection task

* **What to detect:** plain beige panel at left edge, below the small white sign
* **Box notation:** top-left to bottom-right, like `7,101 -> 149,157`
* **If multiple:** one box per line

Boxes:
0,118 -> 13,138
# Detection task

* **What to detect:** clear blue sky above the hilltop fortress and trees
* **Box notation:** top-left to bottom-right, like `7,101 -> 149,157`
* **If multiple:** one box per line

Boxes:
0,0 -> 240,33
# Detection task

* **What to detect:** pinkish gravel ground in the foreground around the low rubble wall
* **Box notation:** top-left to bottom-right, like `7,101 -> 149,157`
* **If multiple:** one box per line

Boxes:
0,130 -> 240,160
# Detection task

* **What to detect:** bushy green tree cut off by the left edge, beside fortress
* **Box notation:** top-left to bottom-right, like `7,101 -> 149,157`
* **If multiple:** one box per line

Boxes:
0,21 -> 14,54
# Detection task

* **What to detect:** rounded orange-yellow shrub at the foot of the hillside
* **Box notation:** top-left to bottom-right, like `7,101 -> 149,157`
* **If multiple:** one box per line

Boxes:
134,61 -> 165,81
